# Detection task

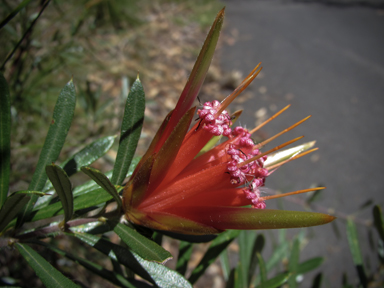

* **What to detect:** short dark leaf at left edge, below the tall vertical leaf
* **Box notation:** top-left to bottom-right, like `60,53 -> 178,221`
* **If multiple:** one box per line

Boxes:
0,193 -> 30,232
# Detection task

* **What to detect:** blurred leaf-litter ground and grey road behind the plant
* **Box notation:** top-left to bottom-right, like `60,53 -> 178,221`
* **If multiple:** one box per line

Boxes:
0,0 -> 384,287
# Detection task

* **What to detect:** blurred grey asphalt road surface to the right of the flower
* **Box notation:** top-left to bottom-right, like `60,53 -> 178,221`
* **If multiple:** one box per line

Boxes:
220,0 -> 384,287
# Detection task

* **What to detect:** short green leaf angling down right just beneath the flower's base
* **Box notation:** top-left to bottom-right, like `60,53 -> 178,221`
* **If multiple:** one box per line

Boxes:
113,223 -> 172,263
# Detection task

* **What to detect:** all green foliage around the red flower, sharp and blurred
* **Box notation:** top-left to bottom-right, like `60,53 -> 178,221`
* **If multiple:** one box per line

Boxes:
0,0 -> 384,288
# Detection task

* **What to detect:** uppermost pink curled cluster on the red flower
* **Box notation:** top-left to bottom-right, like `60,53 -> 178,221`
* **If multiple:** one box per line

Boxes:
197,100 -> 232,137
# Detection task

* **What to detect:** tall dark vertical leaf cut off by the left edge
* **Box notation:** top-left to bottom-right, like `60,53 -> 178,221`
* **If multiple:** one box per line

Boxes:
0,73 -> 11,208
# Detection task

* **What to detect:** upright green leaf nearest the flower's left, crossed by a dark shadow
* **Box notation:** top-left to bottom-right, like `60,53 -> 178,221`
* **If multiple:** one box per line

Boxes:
111,77 -> 145,185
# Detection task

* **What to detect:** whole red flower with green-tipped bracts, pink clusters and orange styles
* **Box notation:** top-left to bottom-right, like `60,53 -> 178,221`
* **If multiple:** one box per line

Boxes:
123,9 -> 334,235
